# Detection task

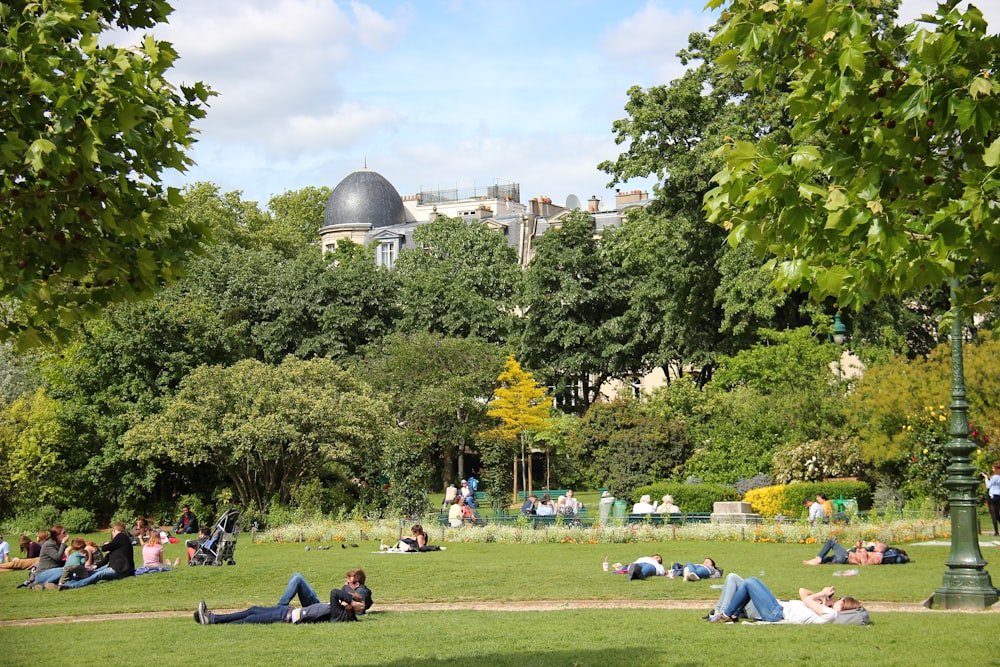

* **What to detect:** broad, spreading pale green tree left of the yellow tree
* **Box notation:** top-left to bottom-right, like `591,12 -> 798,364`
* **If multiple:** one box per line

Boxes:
123,357 -> 391,508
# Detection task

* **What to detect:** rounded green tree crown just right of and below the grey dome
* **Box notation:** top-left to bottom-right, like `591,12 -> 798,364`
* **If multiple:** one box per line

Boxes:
393,217 -> 520,344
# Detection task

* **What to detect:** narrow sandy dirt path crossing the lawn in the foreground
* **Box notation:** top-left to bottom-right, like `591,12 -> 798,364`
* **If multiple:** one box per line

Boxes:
0,600 -> 984,627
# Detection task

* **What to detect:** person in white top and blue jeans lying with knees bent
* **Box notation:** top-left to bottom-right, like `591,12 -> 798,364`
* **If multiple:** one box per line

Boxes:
707,577 -> 861,625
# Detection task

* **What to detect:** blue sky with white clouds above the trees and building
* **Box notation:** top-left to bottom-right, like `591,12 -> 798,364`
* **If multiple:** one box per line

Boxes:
145,0 -> 1000,206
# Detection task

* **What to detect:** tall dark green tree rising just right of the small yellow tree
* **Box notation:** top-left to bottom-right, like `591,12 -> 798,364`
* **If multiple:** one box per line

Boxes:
519,211 -> 625,413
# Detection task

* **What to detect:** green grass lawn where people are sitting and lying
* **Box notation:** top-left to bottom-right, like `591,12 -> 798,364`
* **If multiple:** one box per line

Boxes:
0,535 -> 1000,667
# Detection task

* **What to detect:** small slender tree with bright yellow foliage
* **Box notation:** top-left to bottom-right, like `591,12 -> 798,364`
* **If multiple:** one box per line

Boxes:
482,354 -> 551,500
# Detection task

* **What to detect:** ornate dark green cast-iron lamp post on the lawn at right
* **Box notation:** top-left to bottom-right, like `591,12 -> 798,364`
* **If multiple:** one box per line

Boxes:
930,279 -> 1000,610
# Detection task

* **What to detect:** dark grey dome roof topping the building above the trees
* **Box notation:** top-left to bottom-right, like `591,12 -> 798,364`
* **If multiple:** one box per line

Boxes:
323,169 -> 406,228
